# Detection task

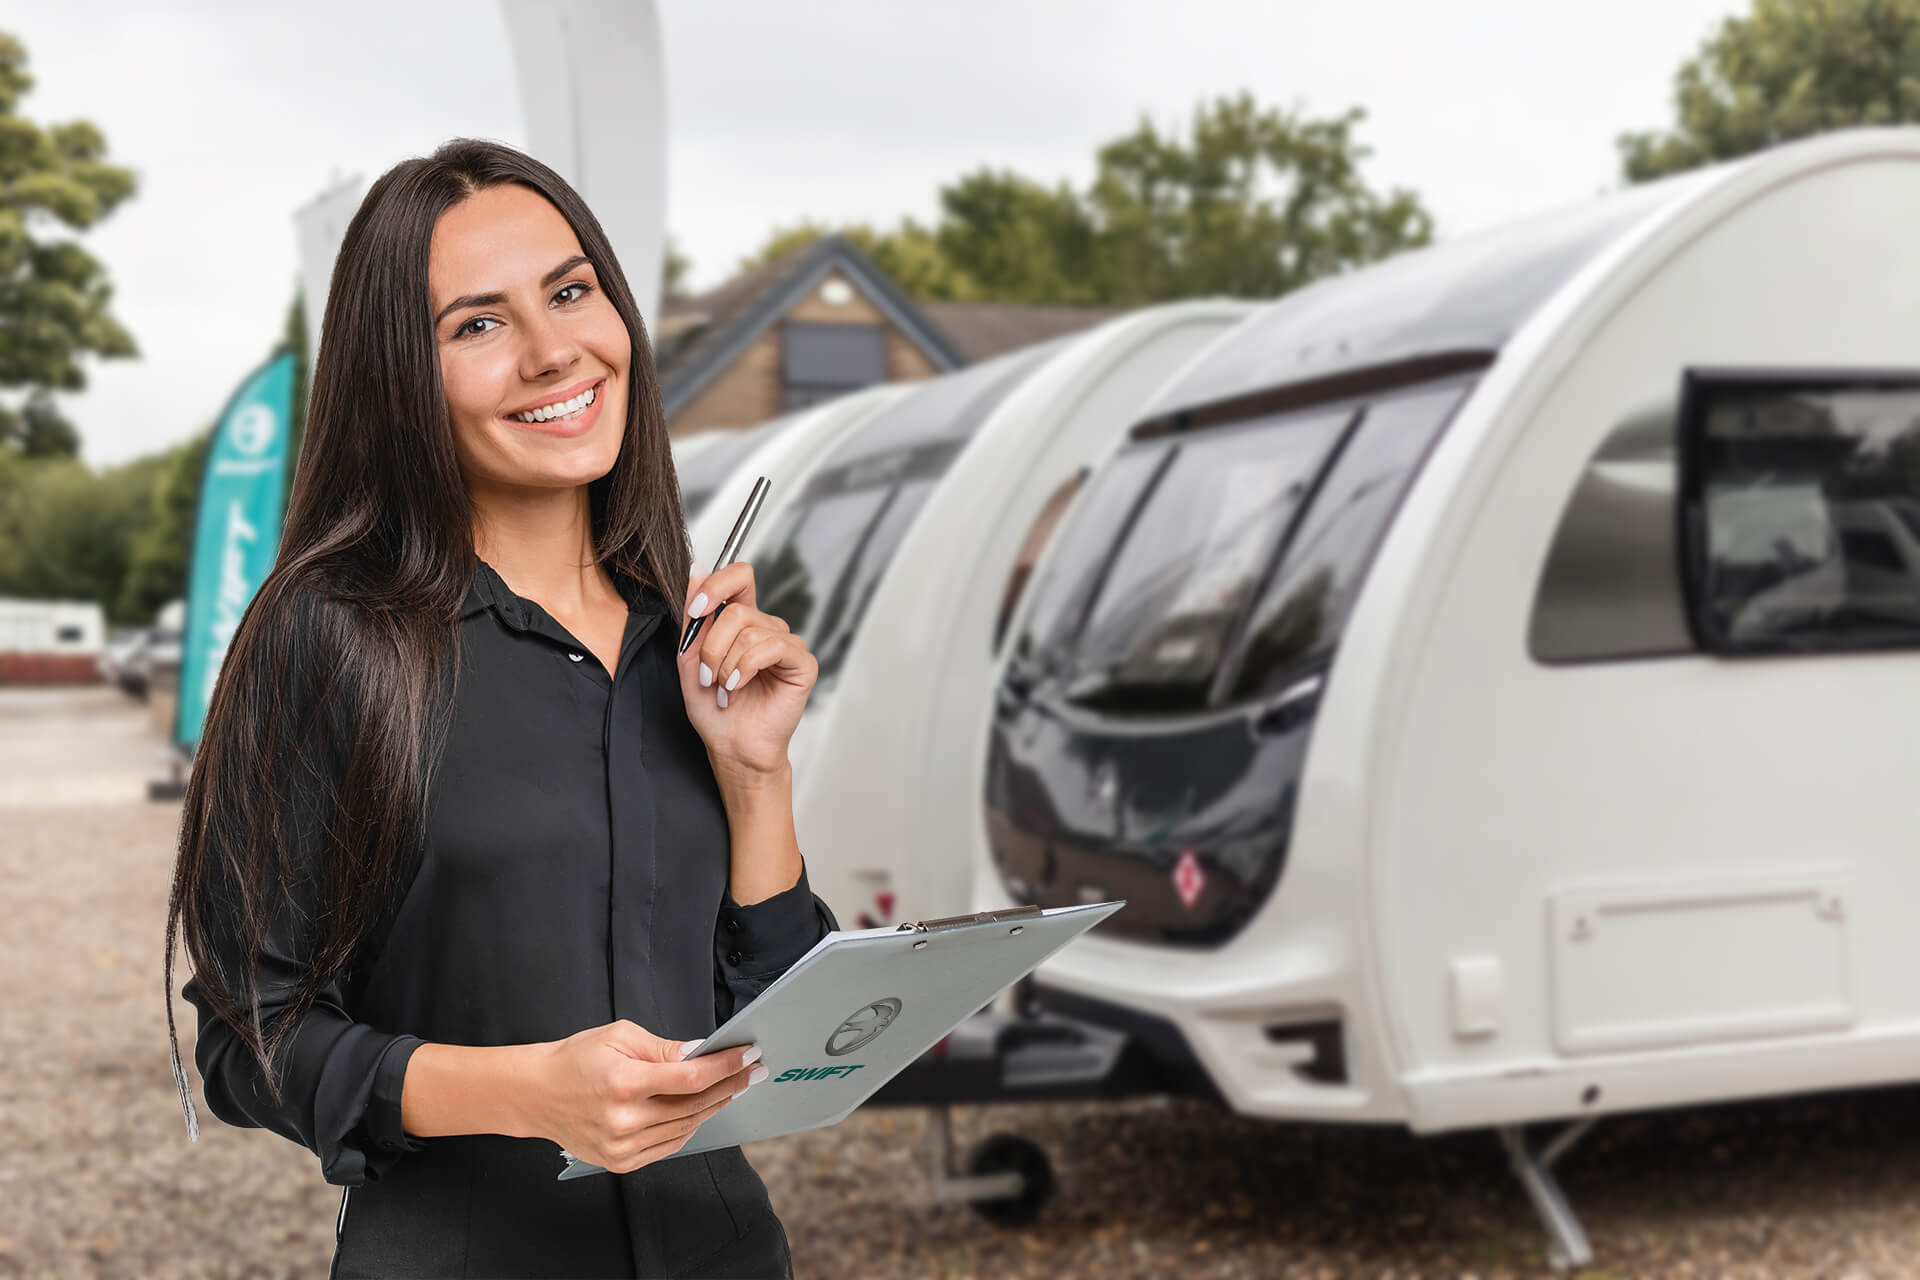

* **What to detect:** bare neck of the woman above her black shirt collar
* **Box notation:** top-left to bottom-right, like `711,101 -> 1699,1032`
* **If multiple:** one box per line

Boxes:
467,482 -> 614,614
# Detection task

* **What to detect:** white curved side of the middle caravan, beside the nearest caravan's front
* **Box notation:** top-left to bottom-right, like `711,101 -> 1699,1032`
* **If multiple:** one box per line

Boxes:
793,301 -> 1256,929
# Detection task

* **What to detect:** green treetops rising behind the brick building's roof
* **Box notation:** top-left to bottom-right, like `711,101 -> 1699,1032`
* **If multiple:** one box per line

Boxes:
741,94 -> 1432,307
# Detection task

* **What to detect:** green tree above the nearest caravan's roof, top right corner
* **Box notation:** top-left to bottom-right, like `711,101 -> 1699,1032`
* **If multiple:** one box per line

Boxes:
1619,0 -> 1920,182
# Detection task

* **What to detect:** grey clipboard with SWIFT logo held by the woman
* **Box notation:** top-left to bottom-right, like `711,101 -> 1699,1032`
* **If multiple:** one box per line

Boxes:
559,900 -> 1127,1180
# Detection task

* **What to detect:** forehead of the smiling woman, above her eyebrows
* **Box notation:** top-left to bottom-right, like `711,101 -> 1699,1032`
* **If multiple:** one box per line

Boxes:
426,186 -> 580,307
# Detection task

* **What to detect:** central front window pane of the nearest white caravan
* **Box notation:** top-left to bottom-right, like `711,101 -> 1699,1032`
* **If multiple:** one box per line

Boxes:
1064,411 -> 1352,714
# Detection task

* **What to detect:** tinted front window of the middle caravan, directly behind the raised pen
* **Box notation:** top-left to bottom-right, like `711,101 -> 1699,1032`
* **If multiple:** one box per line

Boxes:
756,344 -> 1056,679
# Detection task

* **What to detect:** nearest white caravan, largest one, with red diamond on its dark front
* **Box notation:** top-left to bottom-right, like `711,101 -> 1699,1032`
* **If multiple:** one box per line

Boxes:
967,129 -> 1920,1261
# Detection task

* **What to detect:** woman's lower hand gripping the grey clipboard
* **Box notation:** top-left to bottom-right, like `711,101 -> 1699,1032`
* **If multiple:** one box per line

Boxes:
532,1019 -> 766,1173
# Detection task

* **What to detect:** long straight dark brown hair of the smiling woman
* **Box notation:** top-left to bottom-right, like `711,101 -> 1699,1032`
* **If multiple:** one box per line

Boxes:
165,138 -> 691,1136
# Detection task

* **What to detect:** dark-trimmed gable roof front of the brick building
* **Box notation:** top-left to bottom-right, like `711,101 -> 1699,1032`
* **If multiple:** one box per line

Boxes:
653,234 -> 968,418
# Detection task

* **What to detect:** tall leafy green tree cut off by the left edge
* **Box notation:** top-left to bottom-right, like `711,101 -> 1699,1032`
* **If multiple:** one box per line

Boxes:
0,33 -> 136,453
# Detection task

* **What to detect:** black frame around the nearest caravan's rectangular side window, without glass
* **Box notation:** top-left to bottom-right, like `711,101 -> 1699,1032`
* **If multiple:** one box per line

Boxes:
1674,365 -> 1920,660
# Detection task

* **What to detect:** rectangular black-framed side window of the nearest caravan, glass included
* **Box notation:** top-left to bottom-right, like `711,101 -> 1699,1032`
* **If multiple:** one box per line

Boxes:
1682,372 -> 1920,654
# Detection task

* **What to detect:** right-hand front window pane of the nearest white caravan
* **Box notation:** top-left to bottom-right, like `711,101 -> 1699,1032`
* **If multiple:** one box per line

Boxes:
1227,382 -> 1471,699
